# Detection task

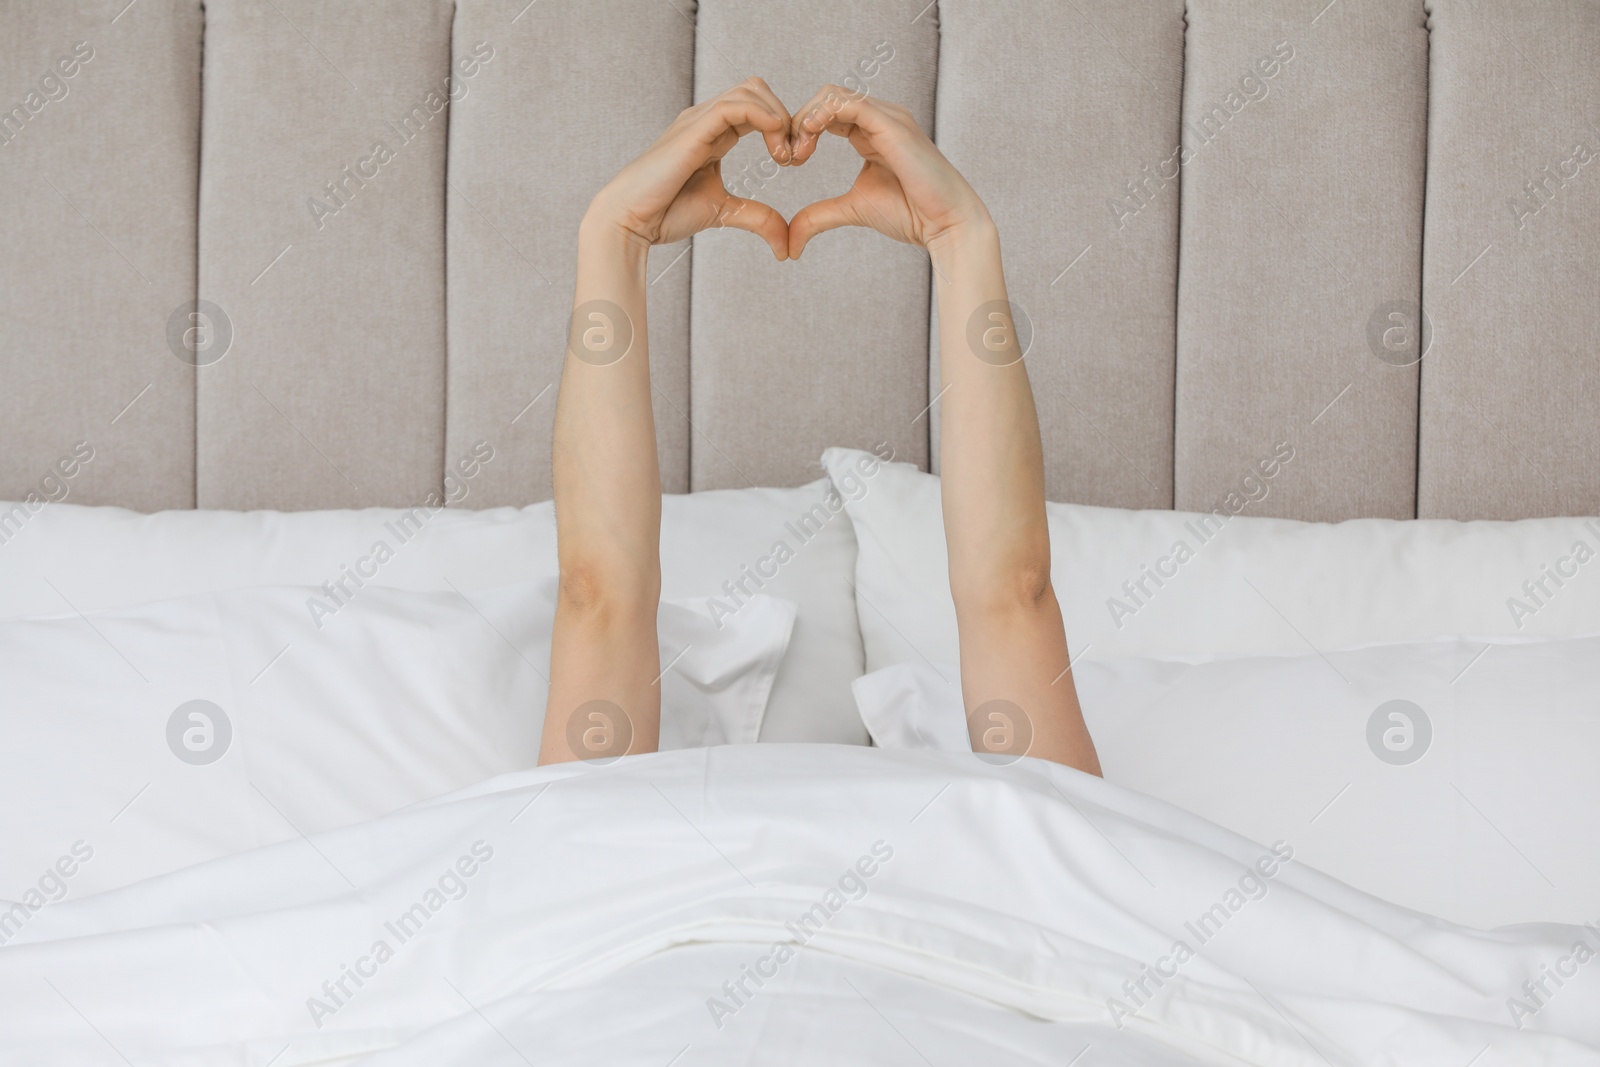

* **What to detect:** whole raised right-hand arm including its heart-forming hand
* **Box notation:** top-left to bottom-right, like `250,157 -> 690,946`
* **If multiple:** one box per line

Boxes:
789,86 -> 1099,774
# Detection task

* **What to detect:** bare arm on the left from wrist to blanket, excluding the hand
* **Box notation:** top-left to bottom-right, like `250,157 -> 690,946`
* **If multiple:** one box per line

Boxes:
539,219 -> 661,763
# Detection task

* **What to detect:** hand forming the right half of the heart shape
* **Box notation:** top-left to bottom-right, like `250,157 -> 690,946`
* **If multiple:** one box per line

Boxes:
789,85 -> 994,259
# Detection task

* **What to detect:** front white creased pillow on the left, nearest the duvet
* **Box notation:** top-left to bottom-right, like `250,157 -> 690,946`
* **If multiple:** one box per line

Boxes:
0,579 -> 795,895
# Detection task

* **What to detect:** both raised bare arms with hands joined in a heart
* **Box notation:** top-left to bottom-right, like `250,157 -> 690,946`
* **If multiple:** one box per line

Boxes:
539,78 -> 1099,774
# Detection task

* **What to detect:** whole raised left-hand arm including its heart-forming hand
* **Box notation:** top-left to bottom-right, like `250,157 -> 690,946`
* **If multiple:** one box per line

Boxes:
539,78 -> 789,765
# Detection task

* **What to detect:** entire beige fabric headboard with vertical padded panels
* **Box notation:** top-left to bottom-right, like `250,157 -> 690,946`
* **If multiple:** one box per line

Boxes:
0,0 -> 1600,520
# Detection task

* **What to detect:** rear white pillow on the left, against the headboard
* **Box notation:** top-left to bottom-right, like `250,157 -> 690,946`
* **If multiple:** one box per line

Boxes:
0,478 -> 867,744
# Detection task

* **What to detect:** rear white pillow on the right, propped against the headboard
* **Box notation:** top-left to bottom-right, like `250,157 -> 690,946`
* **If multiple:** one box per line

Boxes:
822,448 -> 1600,670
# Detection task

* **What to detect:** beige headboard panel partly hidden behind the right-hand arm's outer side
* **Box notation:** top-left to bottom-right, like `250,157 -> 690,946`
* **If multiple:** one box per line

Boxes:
928,0 -> 1184,507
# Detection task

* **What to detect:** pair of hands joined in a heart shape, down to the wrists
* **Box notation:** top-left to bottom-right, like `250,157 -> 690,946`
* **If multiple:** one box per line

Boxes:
586,78 -> 990,259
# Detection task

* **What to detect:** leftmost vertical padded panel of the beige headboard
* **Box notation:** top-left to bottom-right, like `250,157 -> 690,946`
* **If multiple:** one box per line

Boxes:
0,0 -> 200,511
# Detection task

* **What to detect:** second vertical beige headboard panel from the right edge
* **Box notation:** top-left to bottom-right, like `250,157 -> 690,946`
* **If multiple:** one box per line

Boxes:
1176,0 -> 1427,520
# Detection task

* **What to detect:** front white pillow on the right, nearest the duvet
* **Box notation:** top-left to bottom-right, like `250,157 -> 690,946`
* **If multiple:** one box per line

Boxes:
856,638 -> 1600,928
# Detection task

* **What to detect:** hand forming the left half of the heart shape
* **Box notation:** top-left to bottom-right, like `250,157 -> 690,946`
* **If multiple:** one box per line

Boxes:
584,78 -> 794,259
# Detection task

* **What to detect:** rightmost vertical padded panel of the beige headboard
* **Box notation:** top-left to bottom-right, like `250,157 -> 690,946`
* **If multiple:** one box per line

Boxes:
1418,0 -> 1600,518
